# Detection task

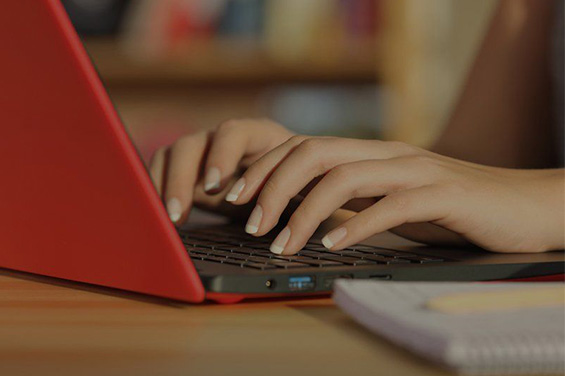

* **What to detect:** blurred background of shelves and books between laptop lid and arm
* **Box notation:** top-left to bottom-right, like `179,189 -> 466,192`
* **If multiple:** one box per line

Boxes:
63,0 -> 496,159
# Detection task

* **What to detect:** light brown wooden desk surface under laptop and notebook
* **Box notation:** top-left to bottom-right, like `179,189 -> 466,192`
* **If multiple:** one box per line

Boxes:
0,269 -> 556,376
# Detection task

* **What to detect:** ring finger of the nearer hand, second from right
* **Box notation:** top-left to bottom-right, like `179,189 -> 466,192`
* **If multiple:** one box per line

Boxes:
266,158 -> 429,255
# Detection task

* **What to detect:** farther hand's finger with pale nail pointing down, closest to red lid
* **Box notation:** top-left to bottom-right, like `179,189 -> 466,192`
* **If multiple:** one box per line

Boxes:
165,132 -> 210,225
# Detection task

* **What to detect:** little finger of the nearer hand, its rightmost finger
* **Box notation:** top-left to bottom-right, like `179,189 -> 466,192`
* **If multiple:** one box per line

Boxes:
322,185 -> 450,250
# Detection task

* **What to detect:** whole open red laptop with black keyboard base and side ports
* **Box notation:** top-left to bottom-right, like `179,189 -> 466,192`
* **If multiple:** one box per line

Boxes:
0,0 -> 564,302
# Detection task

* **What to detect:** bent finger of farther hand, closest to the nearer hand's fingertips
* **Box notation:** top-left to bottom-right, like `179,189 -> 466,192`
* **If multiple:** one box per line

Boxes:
204,119 -> 290,193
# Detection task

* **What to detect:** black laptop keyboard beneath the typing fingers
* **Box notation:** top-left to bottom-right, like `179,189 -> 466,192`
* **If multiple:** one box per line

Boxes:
179,227 -> 445,270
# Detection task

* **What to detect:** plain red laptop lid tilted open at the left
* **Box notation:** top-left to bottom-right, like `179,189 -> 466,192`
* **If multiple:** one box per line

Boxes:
0,0 -> 204,302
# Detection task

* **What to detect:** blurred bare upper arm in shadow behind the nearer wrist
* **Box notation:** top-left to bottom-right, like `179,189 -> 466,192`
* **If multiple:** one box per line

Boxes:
433,0 -> 554,168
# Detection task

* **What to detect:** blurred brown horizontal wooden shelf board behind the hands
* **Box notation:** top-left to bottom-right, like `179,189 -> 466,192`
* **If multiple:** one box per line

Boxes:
84,37 -> 381,86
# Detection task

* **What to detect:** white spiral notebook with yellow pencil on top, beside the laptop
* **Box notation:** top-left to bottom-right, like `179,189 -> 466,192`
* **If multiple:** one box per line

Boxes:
333,280 -> 565,375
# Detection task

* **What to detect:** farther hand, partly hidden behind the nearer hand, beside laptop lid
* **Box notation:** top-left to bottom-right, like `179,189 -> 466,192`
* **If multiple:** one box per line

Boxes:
149,119 -> 294,225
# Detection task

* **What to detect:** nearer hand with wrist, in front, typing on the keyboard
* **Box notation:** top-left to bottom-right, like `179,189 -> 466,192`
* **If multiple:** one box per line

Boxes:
224,136 -> 565,255
